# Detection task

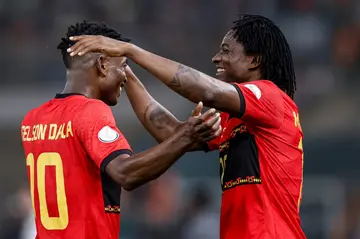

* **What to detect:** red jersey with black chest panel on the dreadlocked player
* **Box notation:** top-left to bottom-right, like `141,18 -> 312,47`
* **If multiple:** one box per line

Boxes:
209,80 -> 306,239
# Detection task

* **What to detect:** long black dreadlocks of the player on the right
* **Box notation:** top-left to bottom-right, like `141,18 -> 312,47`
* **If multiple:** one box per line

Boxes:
232,14 -> 296,99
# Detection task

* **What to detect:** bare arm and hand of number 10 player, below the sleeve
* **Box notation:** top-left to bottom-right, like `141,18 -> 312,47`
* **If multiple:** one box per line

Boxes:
105,109 -> 221,190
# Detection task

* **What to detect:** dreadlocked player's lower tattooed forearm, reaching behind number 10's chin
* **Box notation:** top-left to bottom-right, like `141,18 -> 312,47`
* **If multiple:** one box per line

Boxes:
125,73 -> 182,143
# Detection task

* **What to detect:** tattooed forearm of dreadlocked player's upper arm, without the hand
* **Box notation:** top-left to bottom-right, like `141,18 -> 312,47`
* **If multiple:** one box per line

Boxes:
127,45 -> 232,108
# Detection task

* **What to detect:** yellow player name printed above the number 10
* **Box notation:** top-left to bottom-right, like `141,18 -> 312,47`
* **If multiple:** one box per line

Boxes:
21,121 -> 74,141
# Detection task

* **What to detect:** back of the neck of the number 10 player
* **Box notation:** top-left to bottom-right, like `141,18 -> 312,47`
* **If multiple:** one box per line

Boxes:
61,71 -> 100,99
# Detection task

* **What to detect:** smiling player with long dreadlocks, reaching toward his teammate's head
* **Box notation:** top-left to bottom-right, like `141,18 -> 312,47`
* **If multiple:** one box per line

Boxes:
69,15 -> 305,239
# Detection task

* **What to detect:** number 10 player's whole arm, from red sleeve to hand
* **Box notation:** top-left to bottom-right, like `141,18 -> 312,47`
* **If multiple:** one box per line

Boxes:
77,100 -> 221,190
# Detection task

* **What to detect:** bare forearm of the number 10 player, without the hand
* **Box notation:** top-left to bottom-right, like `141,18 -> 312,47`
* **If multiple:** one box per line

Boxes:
117,133 -> 191,190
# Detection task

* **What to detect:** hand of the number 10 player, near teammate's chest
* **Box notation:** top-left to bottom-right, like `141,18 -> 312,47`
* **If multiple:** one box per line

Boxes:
183,104 -> 222,147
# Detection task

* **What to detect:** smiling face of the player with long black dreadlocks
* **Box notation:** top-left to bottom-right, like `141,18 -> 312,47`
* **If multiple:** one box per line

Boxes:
212,30 -> 259,83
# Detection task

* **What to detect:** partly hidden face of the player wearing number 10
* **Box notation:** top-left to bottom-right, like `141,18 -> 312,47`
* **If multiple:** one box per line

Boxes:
99,57 -> 127,106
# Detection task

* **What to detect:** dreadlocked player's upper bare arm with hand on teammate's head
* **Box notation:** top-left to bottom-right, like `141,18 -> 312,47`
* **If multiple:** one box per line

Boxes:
68,36 -> 241,114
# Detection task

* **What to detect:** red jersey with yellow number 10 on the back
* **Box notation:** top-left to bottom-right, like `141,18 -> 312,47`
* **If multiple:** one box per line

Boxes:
21,94 -> 131,239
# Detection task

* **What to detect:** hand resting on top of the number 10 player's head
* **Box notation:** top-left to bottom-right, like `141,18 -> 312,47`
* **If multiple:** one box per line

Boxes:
67,35 -> 131,57
